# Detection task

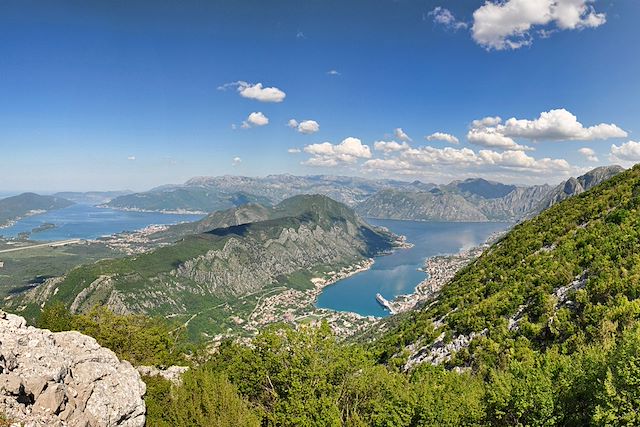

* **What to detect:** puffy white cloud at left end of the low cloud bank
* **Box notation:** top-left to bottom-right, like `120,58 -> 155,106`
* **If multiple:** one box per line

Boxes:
304,137 -> 371,166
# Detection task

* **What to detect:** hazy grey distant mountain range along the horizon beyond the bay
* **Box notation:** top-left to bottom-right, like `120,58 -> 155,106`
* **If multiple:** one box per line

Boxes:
100,166 -> 623,221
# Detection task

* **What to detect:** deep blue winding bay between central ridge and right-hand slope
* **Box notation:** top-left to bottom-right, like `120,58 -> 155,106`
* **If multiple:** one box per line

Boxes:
316,219 -> 512,316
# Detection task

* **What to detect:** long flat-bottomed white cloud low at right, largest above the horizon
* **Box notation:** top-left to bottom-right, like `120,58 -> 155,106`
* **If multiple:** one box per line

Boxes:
467,108 -> 627,151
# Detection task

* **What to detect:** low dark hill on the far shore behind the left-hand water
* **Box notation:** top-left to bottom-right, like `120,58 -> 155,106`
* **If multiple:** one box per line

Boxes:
104,187 -> 271,212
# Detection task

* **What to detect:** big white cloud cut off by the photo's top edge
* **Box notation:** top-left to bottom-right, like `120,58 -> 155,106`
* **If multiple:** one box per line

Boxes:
471,0 -> 606,50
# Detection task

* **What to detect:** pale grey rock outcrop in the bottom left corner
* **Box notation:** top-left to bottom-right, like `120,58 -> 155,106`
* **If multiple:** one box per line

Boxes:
0,312 -> 145,427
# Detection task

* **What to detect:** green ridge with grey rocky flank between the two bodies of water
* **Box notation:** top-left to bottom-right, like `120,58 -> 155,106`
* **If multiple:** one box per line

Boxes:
13,195 -> 395,338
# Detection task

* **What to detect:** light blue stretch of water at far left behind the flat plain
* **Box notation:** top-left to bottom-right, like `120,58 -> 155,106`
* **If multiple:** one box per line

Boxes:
0,204 -> 202,240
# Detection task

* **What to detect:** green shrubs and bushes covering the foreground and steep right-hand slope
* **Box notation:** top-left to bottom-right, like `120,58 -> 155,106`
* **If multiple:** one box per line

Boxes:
27,167 -> 640,427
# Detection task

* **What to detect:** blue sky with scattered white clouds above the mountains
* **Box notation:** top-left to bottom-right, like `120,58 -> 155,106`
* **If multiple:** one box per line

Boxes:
0,0 -> 640,192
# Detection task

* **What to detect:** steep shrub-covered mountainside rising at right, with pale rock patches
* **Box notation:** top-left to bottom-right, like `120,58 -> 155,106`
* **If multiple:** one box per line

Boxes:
376,166 -> 640,378
